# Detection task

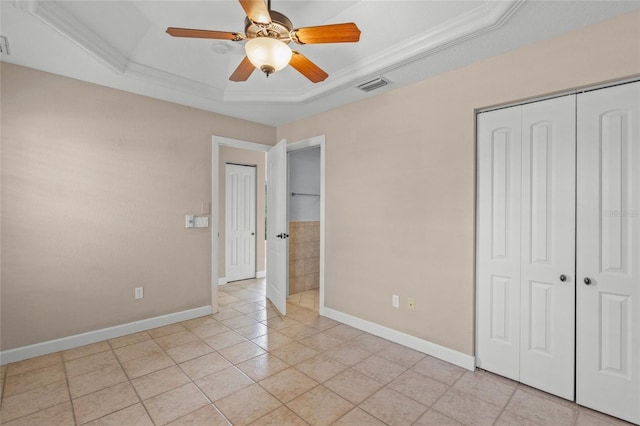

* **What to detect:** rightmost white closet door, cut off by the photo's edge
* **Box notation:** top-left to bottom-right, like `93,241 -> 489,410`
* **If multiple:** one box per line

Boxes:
576,83 -> 640,424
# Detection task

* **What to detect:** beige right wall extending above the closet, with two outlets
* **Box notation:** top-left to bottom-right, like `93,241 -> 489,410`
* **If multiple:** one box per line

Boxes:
278,12 -> 640,354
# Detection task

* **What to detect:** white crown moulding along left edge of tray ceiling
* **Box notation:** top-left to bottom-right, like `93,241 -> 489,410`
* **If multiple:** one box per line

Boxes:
14,0 -> 129,74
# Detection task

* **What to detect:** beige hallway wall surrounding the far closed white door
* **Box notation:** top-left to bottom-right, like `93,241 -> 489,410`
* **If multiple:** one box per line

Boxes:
218,147 -> 266,278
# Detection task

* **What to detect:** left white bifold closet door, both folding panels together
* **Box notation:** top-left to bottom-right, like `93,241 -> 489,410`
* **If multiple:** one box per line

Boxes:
477,96 -> 575,399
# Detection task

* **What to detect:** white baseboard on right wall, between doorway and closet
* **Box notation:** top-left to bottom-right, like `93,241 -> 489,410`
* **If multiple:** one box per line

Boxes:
322,307 -> 475,371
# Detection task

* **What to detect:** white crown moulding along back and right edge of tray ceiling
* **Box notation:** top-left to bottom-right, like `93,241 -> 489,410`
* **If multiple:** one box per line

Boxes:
225,0 -> 525,103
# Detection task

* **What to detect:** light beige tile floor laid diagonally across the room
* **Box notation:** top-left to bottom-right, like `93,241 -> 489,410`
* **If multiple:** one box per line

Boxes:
0,280 -> 625,426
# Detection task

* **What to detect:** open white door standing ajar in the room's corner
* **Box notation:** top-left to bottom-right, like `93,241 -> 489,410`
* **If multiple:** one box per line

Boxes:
267,140 -> 289,315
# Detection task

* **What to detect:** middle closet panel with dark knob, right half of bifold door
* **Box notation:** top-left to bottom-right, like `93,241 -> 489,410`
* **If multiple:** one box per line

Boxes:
520,96 -> 576,399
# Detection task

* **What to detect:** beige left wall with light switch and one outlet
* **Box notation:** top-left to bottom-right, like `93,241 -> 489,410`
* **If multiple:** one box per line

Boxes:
0,63 -> 275,350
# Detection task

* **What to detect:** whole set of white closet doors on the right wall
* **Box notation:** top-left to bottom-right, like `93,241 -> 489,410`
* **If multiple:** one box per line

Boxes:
476,82 -> 640,424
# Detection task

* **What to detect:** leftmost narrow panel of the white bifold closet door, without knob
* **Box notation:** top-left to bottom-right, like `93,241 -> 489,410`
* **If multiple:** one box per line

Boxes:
476,107 -> 521,380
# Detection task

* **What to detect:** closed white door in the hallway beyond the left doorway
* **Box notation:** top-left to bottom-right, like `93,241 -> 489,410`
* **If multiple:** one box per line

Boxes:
225,164 -> 256,281
